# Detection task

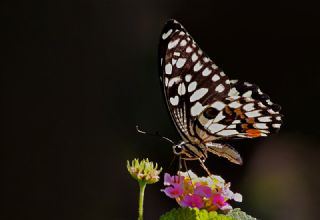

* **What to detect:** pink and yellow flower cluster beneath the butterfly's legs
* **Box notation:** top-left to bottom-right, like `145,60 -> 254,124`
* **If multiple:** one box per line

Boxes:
162,170 -> 242,211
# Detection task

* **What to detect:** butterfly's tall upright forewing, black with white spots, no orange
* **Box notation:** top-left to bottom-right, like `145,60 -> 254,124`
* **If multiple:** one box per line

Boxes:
159,20 -> 230,142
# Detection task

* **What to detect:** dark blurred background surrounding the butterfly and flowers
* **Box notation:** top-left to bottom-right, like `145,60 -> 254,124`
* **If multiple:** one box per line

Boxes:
0,0 -> 320,220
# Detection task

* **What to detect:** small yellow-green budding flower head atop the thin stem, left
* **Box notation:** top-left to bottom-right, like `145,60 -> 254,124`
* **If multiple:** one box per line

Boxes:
127,159 -> 162,184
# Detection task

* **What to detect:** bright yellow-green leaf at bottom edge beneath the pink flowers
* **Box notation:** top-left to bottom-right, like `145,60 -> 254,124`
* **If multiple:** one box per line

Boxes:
160,208 -> 235,220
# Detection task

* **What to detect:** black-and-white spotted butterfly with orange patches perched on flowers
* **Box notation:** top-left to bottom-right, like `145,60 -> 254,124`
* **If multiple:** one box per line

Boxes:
159,20 -> 282,169
